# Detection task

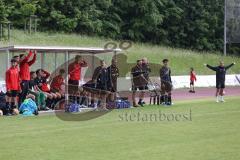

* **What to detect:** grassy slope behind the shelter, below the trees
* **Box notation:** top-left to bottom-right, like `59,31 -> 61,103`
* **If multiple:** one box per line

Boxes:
0,30 -> 240,75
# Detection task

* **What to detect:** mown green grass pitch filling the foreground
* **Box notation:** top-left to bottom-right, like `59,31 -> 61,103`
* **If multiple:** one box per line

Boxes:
0,97 -> 240,160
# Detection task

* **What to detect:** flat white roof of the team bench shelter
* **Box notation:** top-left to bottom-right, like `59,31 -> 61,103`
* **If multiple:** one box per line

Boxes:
0,45 -> 121,54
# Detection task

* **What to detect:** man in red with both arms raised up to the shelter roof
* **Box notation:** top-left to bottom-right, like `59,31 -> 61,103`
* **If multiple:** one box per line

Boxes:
19,51 -> 37,103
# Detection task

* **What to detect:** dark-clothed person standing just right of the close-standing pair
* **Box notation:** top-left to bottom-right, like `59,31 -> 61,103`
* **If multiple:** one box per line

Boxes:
159,59 -> 172,105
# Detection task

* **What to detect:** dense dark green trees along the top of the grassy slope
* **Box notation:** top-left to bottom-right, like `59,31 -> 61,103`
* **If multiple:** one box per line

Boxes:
0,0 -> 232,51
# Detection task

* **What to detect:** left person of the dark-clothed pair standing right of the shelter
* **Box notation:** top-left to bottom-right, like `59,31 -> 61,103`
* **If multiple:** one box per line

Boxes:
131,60 -> 148,107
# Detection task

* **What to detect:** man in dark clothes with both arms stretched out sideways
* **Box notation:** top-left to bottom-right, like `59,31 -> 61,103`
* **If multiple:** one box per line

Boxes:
204,61 -> 236,103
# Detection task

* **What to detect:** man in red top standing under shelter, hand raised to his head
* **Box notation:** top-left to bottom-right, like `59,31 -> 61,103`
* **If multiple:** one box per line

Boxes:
68,55 -> 88,99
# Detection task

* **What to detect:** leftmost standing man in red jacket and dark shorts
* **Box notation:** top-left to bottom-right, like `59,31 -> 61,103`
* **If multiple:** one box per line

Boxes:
6,59 -> 21,115
